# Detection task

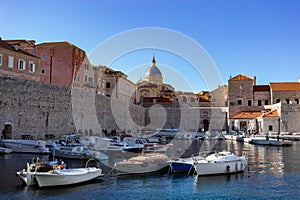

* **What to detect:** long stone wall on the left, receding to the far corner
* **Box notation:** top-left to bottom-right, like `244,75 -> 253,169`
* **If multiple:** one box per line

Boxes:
0,76 -> 145,138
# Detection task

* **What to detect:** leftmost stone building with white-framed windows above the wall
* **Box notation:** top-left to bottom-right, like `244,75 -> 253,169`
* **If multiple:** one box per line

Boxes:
0,38 -> 41,81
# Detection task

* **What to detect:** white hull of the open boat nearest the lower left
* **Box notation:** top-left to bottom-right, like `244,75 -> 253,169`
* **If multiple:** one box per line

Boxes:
34,167 -> 103,187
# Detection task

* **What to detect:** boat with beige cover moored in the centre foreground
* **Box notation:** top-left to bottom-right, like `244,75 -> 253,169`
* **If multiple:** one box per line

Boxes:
114,153 -> 170,174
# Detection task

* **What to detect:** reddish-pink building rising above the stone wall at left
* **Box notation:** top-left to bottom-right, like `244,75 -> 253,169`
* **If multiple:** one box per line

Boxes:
35,42 -> 86,88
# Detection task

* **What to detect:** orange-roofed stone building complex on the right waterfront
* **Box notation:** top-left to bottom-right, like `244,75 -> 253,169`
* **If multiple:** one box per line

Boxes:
228,74 -> 300,133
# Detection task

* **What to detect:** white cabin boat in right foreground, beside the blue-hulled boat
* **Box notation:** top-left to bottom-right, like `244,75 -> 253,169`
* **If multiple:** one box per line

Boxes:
194,151 -> 248,176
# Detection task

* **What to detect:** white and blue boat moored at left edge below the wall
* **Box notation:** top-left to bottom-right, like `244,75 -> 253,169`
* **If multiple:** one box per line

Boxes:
0,139 -> 50,154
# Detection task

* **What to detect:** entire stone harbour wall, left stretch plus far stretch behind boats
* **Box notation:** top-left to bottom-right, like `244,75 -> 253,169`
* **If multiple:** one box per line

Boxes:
0,76 -> 227,138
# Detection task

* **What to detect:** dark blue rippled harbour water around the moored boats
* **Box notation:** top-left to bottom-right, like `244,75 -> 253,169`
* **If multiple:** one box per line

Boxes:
0,141 -> 300,200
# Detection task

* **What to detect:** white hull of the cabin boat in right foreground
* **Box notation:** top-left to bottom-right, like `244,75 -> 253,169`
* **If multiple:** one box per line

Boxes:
194,159 -> 247,176
